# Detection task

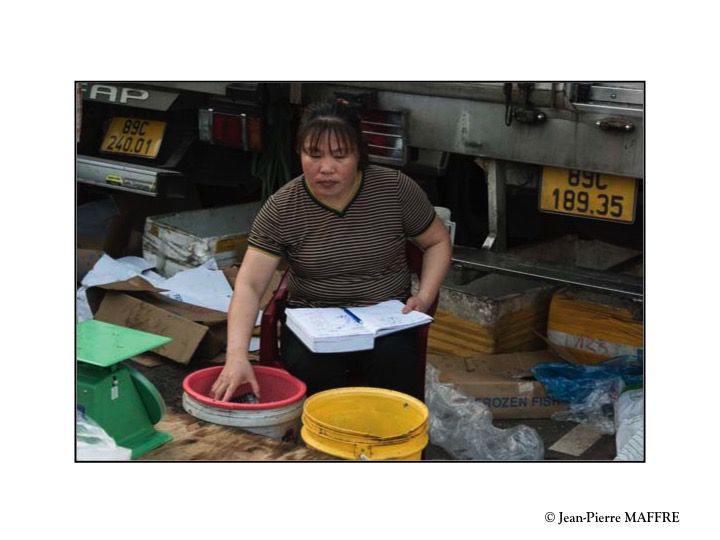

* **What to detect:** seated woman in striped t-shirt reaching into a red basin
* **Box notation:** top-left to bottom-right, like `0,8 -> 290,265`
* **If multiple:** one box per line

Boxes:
210,102 -> 451,400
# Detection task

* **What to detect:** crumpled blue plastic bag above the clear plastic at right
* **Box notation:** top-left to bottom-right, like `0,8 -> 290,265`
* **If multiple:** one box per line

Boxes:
530,355 -> 643,403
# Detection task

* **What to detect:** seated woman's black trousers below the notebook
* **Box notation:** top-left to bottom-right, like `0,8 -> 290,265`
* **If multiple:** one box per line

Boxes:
280,328 -> 418,396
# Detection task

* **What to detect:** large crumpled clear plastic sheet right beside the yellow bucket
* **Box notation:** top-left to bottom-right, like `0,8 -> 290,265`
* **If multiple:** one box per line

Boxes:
425,365 -> 545,461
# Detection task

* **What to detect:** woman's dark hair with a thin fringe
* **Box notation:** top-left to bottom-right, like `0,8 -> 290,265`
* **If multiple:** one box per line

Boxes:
297,101 -> 368,169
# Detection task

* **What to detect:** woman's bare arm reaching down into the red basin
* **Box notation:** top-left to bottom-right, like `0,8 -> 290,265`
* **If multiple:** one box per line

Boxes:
210,247 -> 280,401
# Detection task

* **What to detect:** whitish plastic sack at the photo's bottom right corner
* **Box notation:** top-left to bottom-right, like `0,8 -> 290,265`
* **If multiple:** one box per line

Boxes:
615,388 -> 645,461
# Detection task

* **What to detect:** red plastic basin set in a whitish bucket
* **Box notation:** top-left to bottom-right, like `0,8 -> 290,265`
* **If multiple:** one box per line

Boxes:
183,366 -> 307,411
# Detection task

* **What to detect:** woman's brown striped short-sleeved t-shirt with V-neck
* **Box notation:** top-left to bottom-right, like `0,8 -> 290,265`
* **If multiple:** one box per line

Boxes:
248,165 -> 435,307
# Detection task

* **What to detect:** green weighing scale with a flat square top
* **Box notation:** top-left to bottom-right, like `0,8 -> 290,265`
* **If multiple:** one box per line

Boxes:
75,320 -> 172,459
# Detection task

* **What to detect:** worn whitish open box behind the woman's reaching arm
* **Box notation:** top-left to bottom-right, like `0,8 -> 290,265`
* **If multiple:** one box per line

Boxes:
143,203 -> 260,277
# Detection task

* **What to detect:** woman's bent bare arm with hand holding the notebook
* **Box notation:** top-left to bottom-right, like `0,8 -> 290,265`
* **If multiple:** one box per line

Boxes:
403,216 -> 452,313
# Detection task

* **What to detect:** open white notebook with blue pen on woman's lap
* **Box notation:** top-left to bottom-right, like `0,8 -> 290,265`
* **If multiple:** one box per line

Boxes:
285,300 -> 433,353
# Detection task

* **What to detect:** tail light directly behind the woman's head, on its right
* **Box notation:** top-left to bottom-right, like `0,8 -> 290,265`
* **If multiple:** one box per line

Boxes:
360,110 -> 407,167
